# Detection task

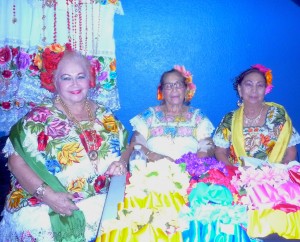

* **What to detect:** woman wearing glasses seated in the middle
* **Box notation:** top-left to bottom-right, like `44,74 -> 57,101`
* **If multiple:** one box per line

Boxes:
130,66 -> 214,161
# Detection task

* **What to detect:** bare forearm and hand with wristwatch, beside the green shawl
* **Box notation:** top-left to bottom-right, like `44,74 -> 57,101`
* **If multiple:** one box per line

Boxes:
8,154 -> 78,215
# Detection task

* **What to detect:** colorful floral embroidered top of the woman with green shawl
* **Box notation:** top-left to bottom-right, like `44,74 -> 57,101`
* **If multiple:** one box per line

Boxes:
7,99 -> 127,211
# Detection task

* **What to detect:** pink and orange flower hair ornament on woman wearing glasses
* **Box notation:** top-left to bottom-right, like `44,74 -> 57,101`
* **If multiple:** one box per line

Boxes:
157,65 -> 196,102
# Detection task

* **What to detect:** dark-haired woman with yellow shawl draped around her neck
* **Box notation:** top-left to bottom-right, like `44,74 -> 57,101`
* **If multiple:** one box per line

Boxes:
213,64 -> 300,165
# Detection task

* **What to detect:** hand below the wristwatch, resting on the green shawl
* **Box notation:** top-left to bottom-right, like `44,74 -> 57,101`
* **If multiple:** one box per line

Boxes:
43,187 -> 79,216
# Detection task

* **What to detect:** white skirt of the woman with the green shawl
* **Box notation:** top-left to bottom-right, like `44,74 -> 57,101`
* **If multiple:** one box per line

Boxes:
0,194 -> 106,242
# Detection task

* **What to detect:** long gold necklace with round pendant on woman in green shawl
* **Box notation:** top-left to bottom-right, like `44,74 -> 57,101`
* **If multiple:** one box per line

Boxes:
56,96 -> 98,162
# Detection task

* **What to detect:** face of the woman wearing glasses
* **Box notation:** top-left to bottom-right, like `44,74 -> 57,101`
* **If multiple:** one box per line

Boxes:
162,73 -> 186,105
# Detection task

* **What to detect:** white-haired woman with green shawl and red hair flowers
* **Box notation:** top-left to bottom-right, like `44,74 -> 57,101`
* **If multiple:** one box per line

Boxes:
0,44 -> 127,241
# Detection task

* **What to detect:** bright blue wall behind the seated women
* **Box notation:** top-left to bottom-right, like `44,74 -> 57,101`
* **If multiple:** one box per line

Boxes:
115,0 -> 300,146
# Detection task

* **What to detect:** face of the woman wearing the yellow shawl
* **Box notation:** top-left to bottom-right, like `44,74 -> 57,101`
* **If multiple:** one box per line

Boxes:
238,72 -> 266,105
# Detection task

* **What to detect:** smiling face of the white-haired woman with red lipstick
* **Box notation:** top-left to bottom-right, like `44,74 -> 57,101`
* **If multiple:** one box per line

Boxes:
55,59 -> 89,105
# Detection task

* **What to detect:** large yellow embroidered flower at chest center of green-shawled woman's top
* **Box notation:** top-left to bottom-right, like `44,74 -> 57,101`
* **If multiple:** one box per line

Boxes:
57,142 -> 83,165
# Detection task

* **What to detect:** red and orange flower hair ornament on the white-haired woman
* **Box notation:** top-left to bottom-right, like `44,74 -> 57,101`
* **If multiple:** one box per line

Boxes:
33,43 -> 95,93
